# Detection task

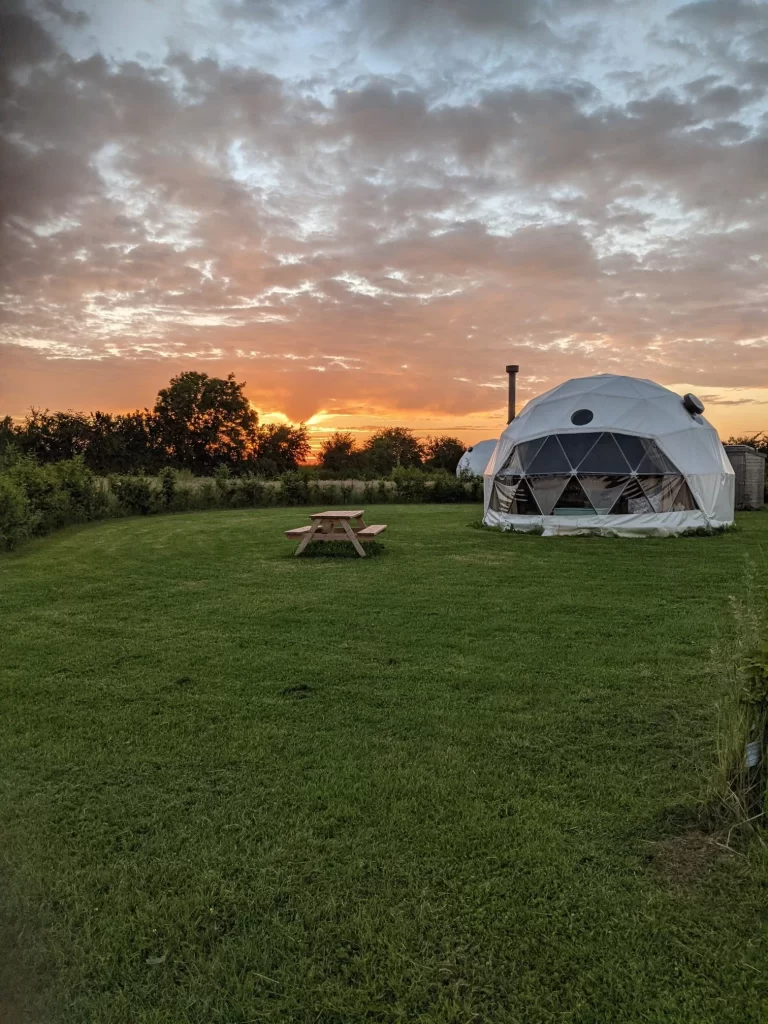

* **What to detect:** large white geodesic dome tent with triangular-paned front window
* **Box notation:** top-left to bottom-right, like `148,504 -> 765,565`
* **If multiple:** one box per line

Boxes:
484,374 -> 734,537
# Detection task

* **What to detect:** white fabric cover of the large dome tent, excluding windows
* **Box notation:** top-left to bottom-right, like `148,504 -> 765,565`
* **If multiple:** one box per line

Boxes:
483,374 -> 735,537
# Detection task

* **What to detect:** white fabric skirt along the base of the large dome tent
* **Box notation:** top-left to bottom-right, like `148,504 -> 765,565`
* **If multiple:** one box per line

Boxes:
482,509 -> 733,538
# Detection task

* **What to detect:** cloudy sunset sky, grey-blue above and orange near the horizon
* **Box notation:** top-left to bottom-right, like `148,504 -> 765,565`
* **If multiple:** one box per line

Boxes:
0,0 -> 768,442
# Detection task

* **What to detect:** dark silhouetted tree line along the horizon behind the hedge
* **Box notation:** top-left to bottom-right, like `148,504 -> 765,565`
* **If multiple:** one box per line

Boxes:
0,371 -> 464,478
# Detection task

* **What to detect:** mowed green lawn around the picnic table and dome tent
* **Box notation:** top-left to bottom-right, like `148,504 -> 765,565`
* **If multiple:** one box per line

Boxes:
0,506 -> 768,1024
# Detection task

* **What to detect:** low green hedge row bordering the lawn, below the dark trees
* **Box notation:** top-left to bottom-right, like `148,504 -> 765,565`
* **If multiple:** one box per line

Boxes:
0,455 -> 482,549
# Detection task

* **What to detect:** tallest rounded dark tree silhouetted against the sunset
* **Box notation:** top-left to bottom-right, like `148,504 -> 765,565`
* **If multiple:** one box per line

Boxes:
155,371 -> 258,473
